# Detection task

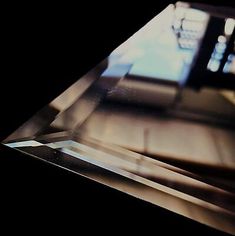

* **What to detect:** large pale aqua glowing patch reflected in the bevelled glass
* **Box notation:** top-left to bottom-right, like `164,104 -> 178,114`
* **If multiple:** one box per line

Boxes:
129,30 -> 188,81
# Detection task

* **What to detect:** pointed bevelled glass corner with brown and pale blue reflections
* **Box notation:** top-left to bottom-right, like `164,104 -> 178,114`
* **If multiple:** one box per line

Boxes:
4,3 -> 235,234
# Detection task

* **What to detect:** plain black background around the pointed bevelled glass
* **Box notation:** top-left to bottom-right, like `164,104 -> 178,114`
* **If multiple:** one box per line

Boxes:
0,1 -> 233,235
